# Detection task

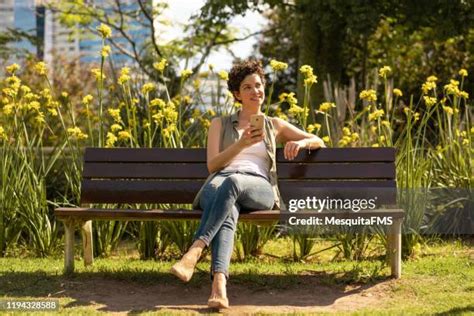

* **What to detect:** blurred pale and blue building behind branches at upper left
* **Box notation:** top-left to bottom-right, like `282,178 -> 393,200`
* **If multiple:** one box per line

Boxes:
0,0 -> 156,64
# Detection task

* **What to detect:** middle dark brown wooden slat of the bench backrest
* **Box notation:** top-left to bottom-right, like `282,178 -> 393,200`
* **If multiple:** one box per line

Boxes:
83,163 -> 395,179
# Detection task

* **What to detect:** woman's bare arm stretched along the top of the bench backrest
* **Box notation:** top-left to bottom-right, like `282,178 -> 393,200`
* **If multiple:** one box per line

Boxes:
272,117 -> 326,160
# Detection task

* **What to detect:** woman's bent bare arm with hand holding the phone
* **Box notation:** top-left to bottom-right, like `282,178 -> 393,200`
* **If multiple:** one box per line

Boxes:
207,118 -> 263,173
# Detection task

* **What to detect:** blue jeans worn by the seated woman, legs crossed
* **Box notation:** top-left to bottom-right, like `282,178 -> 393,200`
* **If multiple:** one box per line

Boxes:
194,171 -> 275,278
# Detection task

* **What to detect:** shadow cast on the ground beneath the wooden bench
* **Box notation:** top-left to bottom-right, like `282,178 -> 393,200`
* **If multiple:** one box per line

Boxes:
0,270 -> 389,313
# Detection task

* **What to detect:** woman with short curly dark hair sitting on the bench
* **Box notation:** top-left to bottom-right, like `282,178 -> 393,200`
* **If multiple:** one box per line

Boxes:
171,60 -> 325,308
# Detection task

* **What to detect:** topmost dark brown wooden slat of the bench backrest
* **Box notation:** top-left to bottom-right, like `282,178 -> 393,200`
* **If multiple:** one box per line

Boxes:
84,147 -> 395,163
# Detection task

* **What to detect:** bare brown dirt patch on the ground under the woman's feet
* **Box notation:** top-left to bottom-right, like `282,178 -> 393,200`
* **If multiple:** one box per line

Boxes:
54,276 -> 393,314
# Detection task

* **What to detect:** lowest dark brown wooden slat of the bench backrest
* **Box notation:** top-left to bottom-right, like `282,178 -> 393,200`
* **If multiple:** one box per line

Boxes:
81,179 -> 396,204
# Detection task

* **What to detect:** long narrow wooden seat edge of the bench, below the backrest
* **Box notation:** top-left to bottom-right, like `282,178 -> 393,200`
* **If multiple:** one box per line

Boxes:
54,208 -> 404,221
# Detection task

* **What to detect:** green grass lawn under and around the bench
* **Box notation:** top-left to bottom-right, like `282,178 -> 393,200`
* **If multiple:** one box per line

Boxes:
0,239 -> 474,315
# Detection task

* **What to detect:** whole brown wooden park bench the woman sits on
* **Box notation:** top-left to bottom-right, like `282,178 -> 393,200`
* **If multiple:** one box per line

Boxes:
55,148 -> 404,278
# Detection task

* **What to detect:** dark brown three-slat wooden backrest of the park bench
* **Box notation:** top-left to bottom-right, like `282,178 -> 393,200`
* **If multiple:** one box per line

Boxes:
81,148 -> 396,205
